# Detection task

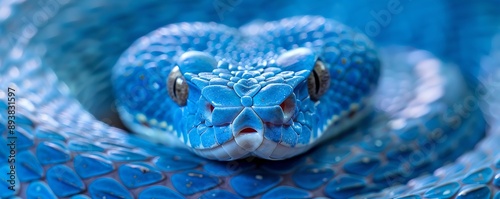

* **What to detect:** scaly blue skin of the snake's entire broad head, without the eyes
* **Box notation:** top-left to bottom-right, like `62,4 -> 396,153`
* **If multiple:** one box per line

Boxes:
113,17 -> 380,160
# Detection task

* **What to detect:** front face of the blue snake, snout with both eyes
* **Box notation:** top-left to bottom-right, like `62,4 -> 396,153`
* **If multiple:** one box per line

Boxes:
168,48 -> 329,160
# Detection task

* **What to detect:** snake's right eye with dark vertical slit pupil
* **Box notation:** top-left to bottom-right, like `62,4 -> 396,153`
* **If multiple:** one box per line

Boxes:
307,60 -> 330,101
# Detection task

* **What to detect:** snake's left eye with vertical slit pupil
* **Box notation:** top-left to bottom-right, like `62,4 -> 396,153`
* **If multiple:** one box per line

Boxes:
167,66 -> 188,106
